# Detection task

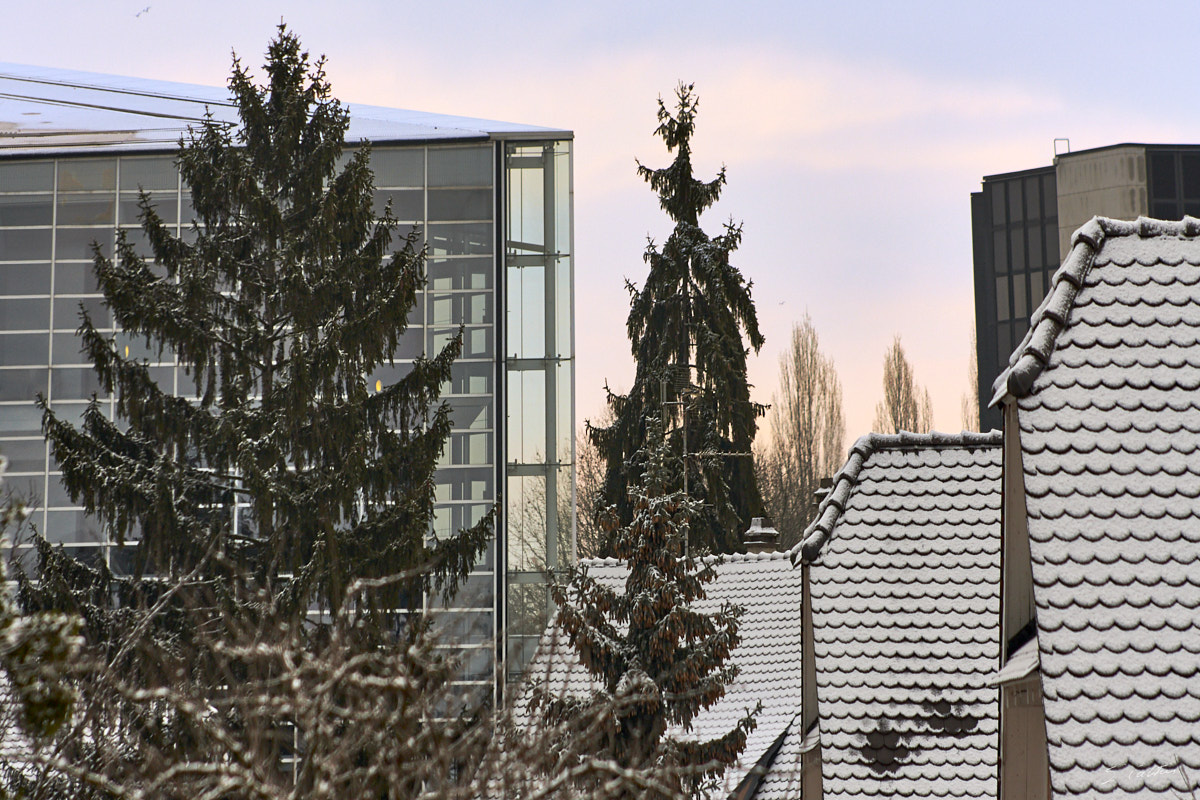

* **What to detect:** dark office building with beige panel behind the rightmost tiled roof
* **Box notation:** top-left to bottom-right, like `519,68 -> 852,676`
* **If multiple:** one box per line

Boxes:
971,144 -> 1200,431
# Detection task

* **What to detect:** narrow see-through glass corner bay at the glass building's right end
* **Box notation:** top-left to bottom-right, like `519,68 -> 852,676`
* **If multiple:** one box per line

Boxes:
504,142 -> 575,681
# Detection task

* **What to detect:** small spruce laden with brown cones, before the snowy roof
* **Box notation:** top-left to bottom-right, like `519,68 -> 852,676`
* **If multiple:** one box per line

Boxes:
532,419 -> 757,798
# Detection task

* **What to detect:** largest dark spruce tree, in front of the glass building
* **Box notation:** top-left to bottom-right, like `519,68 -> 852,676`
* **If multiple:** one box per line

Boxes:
37,28 -> 487,607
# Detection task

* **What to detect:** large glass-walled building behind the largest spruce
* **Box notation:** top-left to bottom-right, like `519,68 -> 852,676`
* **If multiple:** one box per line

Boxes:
0,67 -> 575,696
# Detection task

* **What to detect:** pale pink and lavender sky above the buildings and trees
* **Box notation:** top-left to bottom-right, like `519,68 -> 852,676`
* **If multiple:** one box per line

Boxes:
0,0 -> 1200,446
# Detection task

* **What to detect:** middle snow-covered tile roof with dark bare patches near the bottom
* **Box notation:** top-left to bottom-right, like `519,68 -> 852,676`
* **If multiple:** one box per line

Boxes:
793,432 -> 1002,798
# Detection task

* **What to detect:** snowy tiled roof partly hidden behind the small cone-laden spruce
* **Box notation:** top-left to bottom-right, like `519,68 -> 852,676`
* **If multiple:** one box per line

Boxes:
526,552 -> 803,798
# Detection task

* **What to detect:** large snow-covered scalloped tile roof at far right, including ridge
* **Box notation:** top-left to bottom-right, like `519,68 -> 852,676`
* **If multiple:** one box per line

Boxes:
996,217 -> 1200,798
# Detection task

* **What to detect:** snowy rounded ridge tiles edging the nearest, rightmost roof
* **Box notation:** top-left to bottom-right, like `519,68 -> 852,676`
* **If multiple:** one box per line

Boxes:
988,217 -> 1200,407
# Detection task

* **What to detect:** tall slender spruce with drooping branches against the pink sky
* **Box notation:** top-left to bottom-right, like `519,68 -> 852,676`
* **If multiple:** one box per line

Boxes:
589,84 -> 764,553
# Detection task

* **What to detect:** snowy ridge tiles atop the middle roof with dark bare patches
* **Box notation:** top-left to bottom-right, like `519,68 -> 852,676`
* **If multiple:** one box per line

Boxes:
787,429 -> 1003,564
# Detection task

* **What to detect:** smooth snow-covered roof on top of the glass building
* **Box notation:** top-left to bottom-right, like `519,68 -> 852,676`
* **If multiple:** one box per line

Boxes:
0,62 -> 571,155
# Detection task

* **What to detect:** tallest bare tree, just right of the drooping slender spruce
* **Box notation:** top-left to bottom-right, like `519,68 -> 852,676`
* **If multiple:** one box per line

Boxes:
755,314 -> 846,548
